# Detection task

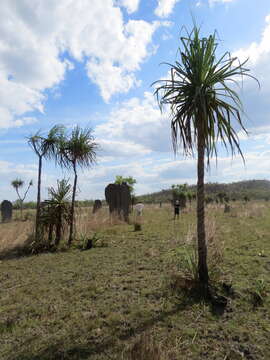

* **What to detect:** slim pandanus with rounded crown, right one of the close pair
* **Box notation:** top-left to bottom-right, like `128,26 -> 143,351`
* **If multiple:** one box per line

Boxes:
58,126 -> 99,246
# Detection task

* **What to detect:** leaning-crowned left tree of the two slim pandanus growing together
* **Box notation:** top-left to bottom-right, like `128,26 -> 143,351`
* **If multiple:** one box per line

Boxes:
28,125 -> 65,240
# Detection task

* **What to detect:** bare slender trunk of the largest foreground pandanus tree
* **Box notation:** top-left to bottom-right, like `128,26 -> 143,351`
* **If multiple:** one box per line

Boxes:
197,122 -> 209,290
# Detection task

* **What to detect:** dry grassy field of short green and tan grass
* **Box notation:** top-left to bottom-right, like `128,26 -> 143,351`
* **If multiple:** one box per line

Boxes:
0,202 -> 270,360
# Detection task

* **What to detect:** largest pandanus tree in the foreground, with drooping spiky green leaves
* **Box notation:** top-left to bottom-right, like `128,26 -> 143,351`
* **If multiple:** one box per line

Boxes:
153,25 -> 257,291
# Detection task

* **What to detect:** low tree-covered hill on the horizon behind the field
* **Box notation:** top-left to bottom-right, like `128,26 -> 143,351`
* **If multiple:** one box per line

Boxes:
137,180 -> 270,203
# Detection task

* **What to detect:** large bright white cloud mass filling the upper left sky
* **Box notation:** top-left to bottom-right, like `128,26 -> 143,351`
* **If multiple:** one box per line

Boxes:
0,0 -> 162,128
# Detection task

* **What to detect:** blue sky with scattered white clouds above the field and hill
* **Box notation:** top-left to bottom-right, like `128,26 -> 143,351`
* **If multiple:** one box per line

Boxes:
0,0 -> 270,200
